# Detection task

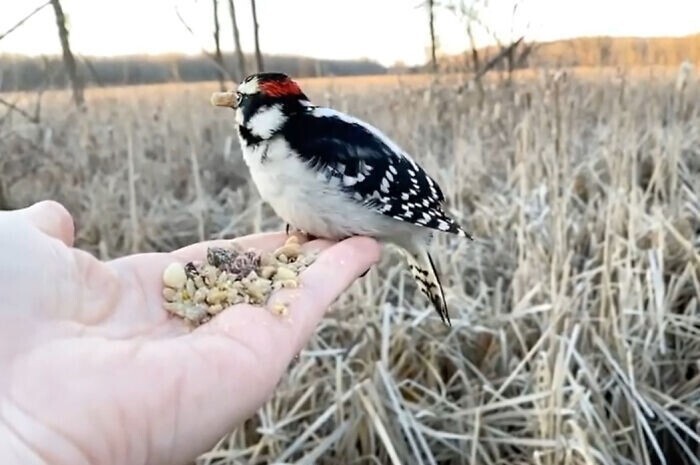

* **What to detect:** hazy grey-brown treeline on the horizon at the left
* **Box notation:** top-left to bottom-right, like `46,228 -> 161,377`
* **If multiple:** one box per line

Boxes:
0,55 -> 386,91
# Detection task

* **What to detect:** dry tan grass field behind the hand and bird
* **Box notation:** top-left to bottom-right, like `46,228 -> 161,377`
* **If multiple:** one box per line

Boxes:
0,69 -> 700,465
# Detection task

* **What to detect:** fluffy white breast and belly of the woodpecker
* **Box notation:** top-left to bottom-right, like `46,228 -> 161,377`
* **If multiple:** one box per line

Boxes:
243,139 -> 403,239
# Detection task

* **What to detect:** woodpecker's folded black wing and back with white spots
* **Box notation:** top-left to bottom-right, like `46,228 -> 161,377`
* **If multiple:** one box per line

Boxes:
282,107 -> 469,237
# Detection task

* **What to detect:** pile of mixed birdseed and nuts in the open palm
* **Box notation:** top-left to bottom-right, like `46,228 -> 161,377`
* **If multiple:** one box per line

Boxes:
163,236 -> 316,326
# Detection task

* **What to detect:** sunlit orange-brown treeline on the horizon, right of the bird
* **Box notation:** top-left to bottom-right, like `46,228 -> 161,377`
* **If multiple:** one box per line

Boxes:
441,34 -> 700,70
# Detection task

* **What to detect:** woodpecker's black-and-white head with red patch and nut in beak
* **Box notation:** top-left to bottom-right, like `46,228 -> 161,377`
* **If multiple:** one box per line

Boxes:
212,73 -> 309,144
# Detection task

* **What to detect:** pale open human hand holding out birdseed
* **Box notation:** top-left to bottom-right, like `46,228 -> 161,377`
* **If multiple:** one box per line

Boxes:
0,202 -> 380,465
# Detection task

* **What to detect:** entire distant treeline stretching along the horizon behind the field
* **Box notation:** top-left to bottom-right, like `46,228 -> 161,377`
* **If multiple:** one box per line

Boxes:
0,34 -> 700,91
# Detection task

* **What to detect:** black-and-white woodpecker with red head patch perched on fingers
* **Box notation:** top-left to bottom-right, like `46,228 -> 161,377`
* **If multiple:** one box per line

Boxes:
212,73 -> 471,325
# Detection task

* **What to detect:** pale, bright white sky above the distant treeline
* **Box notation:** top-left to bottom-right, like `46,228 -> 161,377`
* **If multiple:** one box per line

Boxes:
0,0 -> 700,65
